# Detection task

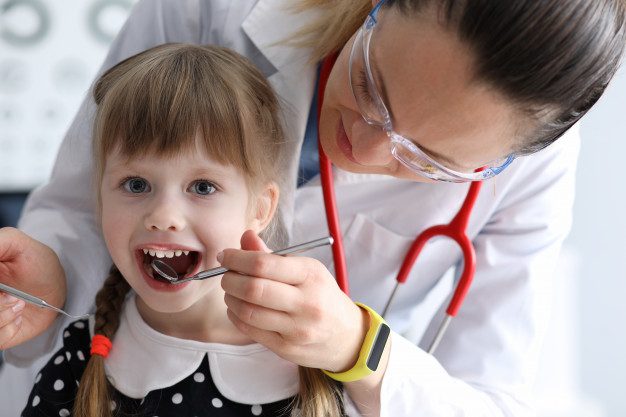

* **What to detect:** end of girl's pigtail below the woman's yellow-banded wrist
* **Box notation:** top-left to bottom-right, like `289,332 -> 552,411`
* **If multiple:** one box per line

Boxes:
293,366 -> 343,417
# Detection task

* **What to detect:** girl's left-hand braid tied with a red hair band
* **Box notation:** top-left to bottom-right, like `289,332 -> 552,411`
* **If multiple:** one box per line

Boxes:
72,266 -> 130,417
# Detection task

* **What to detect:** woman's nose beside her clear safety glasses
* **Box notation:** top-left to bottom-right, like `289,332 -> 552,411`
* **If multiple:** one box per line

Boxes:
347,119 -> 393,166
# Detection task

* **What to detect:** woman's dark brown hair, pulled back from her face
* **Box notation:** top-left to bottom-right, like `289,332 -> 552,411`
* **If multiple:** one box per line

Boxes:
297,0 -> 626,154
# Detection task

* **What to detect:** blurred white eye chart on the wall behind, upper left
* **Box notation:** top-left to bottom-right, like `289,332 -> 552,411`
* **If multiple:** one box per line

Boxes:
0,0 -> 135,192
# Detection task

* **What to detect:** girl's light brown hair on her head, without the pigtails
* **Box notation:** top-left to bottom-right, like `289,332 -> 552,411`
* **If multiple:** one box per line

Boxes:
93,44 -> 285,200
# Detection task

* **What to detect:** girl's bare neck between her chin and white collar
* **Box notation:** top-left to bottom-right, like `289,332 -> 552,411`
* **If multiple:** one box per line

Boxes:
135,295 -> 254,345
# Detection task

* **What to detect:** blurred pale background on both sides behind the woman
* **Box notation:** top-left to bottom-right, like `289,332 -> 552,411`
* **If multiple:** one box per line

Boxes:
0,0 -> 626,417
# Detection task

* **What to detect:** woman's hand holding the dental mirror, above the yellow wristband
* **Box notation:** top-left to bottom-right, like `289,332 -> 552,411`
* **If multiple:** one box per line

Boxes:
221,231 -> 369,372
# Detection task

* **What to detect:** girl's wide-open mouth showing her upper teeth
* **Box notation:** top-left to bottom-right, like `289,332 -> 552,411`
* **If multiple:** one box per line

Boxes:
138,248 -> 201,283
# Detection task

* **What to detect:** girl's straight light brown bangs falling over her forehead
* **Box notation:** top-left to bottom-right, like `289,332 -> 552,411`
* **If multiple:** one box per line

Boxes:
96,50 -> 249,171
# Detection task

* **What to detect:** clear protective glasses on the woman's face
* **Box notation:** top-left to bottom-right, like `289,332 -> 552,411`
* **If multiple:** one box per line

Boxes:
348,0 -> 515,182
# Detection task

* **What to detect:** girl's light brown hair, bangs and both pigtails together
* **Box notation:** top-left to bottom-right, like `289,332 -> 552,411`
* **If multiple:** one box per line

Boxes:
74,44 -> 341,417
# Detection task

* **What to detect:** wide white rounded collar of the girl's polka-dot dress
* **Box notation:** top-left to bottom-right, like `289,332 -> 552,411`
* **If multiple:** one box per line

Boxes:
97,295 -> 299,404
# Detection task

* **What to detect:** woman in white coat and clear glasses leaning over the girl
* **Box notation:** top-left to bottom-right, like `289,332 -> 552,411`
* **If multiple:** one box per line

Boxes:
0,0 -> 626,417
